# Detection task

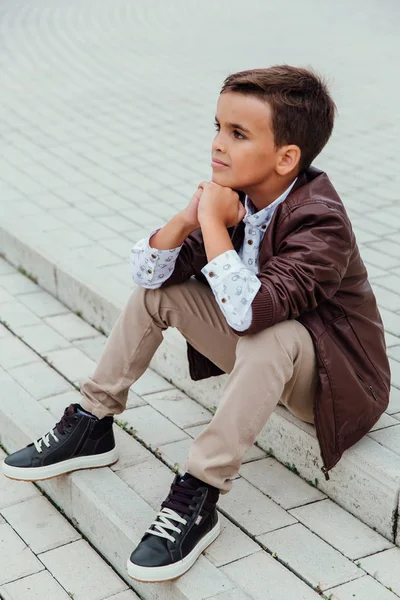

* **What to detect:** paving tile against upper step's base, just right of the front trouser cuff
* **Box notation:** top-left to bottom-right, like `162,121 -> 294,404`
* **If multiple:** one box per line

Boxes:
239,458 -> 326,510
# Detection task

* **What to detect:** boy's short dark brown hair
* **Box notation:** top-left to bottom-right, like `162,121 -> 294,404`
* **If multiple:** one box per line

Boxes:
221,65 -> 336,171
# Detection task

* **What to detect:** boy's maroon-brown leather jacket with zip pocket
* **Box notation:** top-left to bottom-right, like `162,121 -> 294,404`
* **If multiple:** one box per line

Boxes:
163,167 -> 390,479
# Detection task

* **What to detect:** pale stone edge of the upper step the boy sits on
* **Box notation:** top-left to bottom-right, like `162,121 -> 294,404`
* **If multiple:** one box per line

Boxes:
0,219 -> 400,545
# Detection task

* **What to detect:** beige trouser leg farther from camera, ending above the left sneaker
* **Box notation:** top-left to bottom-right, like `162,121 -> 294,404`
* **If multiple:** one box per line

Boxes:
80,279 -> 238,418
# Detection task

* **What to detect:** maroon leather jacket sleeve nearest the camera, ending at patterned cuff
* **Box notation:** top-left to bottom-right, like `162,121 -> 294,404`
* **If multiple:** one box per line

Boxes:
233,202 -> 353,335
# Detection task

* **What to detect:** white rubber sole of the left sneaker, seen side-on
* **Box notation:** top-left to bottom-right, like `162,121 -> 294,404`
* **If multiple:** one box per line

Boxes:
2,447 -> 118,481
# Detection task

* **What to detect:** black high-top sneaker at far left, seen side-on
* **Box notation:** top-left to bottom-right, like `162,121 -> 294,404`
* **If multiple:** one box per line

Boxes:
3,404 -> 118,481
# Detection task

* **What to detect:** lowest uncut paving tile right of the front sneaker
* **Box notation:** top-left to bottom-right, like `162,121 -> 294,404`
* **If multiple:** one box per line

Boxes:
257,523 -> 363,590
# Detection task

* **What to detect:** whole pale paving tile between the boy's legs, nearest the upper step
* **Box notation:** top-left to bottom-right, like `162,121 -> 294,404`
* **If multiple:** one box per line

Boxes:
146,390 -> 213,429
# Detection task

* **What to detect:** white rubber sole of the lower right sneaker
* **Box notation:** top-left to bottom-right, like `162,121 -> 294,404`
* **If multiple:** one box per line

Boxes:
127,518 -> 221,583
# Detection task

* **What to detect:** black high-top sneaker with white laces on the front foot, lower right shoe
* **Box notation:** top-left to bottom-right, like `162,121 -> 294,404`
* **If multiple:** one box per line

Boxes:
127,473 -> 220,582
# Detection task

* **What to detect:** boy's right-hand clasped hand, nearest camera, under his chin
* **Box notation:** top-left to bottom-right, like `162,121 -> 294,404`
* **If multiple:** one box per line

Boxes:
198,181 -> 246,227
